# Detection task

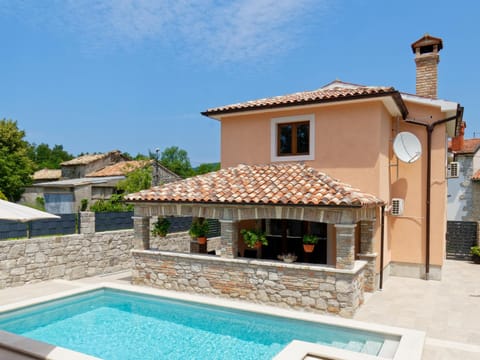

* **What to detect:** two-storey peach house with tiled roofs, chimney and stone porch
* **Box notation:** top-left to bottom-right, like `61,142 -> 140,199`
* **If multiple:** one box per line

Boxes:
127,35 -> 463,316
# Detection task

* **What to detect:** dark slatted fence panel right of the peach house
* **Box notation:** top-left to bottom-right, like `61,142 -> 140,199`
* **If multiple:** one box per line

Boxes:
447,221 -> 477,259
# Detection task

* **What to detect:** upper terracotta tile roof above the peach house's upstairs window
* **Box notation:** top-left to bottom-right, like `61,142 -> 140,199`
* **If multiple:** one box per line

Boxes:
202,81 -> 407,116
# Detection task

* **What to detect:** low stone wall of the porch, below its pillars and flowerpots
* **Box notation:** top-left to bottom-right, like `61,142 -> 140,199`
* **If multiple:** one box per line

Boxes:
132,250 -> 366,317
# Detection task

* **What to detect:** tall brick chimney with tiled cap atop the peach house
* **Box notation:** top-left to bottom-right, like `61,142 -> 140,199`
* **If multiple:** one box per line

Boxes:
412,34 -> 443,99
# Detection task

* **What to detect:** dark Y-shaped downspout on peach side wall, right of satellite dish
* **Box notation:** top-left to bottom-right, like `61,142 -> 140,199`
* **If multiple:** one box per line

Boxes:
405,106 -> 463,280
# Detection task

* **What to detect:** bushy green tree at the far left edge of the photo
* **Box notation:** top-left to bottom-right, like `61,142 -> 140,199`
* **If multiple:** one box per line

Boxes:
0,119 -> 33,201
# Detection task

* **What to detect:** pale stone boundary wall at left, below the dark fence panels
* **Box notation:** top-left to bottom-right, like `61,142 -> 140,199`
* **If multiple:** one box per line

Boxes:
0,230 -> 133,289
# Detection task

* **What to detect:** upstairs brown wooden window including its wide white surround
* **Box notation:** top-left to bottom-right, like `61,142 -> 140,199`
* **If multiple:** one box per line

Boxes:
271,115 -> 315,161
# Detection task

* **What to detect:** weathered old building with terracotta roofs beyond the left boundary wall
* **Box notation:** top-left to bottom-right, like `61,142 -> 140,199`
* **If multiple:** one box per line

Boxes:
21,150 -> 181,214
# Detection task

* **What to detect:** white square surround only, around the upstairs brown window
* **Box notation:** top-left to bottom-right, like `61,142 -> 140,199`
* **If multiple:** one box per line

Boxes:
270,114 -> 315,162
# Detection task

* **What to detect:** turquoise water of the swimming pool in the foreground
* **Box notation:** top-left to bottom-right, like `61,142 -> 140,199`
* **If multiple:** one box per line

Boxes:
0,289 -> 390,360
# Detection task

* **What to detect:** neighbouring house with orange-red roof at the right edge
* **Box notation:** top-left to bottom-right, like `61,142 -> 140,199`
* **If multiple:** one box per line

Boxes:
447,126 -> 480,221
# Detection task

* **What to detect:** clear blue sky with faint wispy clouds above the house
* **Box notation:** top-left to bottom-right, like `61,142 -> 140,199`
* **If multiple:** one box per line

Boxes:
0,0 -> 480,166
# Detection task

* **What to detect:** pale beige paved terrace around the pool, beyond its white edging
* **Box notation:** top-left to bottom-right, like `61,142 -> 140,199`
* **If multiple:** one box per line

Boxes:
0,260 -> 480,360
